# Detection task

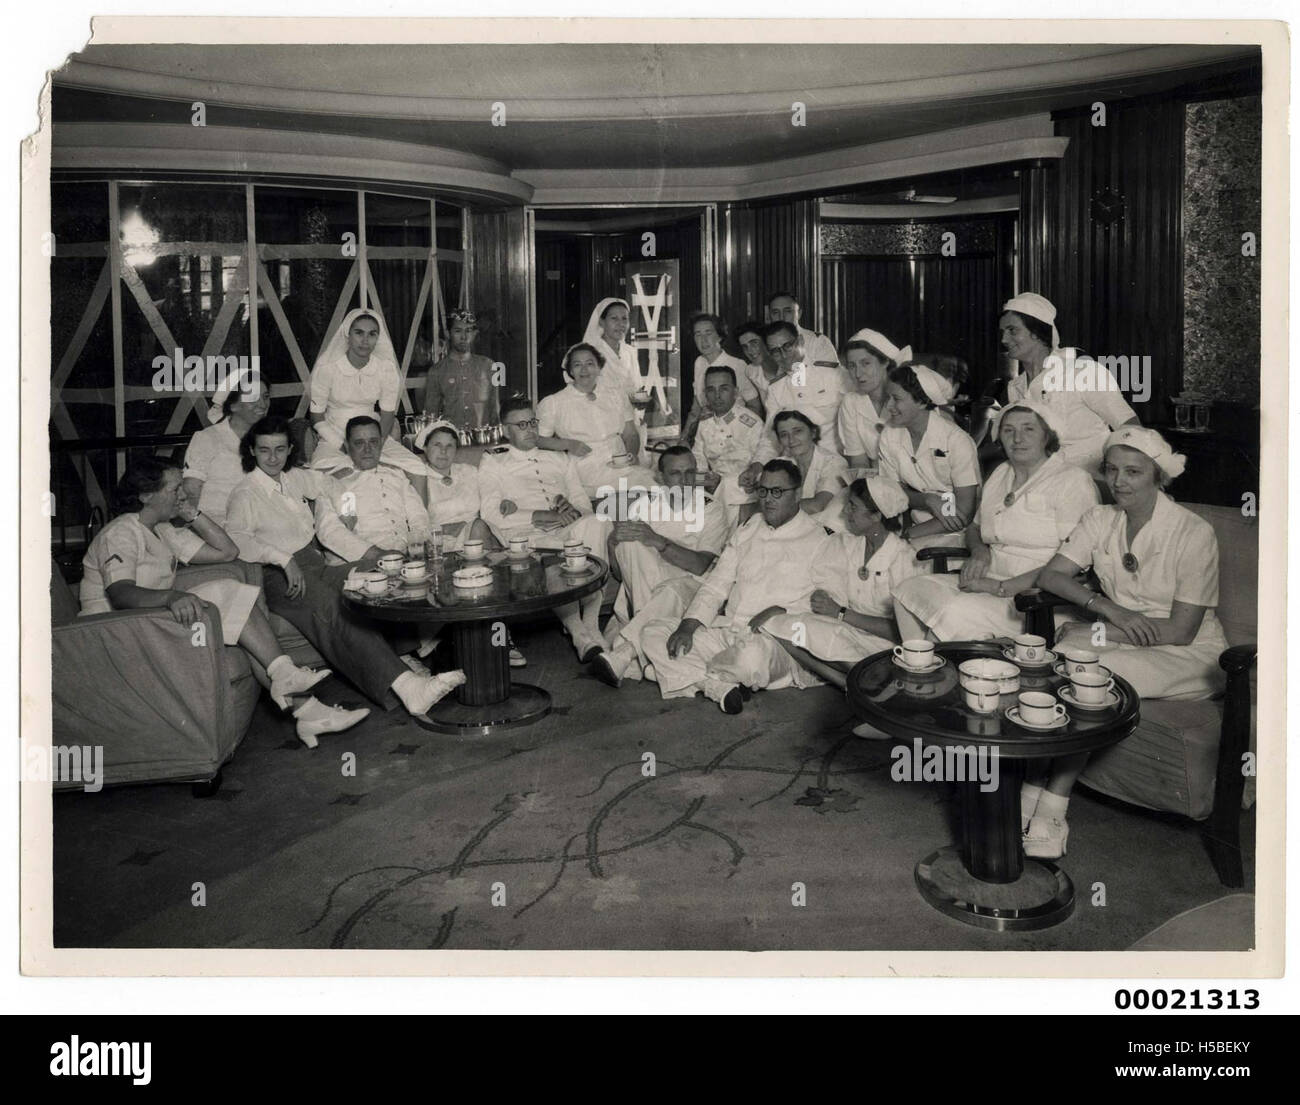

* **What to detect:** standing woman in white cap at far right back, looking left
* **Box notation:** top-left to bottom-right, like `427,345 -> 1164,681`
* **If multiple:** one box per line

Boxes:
998,291 -> 1140,477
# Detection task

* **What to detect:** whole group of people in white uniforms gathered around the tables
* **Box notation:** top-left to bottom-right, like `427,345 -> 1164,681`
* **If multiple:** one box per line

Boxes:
82,293 -> 1226,857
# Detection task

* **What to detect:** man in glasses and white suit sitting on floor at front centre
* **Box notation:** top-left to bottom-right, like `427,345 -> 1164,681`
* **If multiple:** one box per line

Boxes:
641,459 -> 827,714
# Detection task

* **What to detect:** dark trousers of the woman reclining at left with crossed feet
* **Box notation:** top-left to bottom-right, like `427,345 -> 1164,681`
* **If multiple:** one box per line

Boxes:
263,545 -> 407,710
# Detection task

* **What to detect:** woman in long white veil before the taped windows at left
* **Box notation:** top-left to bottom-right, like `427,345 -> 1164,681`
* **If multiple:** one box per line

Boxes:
309,307 -> 428,490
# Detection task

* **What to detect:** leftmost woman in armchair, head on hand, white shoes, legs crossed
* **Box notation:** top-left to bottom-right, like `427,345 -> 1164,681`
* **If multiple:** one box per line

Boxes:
81,456 -> 371,745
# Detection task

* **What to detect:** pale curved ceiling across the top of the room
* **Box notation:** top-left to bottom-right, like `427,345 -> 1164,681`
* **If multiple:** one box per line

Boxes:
53,43 -> 1260,200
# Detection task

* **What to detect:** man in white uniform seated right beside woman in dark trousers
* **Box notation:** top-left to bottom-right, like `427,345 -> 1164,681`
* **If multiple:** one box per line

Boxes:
316,415 -> 429,564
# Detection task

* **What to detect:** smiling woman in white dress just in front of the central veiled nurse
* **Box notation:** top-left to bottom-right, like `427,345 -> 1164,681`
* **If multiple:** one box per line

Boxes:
537,342 -> 655,498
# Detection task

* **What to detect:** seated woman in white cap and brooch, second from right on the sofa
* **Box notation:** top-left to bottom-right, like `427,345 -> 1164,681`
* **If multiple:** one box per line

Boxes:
894,399 -> 1099,641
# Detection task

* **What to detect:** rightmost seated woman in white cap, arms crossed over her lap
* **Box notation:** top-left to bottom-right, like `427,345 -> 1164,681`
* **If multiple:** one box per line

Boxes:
1021,426 -> 1227,859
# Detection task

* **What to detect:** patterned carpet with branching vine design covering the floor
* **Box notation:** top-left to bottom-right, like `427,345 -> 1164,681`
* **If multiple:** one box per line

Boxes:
55,625 -> 1253,950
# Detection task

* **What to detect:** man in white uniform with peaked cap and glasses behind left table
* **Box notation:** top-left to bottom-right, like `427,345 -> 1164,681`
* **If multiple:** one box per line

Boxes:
478,395 -> 610,663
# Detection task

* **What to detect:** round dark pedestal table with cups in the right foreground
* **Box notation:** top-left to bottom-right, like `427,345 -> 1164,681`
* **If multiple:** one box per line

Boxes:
846,641 -> 1139,931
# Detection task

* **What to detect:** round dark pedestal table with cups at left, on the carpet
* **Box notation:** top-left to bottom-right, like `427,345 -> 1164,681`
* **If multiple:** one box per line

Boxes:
343,551 -> 610,736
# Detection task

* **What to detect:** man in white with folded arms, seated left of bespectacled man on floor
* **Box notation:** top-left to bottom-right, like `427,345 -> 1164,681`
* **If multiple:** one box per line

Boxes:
592,441 -> 738,688
